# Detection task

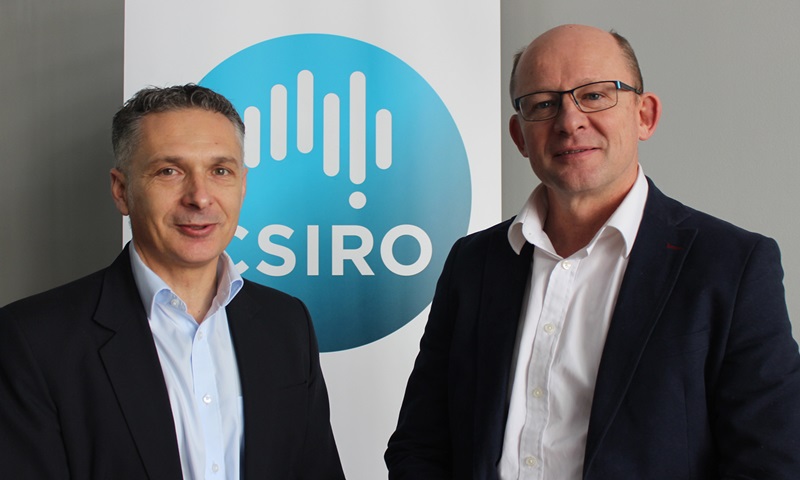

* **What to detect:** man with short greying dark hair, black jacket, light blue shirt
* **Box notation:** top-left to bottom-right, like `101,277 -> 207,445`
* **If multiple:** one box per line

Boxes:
0,85 -> 344,480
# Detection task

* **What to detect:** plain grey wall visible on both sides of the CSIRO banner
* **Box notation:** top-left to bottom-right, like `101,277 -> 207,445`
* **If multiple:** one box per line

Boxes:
0,0 -> 800,342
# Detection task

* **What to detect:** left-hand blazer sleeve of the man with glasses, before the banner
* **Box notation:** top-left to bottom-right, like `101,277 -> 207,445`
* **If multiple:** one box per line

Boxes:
384,240 -> 462,480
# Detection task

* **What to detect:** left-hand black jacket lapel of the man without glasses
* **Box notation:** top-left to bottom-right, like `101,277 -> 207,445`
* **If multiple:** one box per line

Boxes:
95,248 -> 182,479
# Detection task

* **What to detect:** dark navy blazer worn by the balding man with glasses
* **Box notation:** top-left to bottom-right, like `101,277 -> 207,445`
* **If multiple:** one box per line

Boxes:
386,183 -> 800,480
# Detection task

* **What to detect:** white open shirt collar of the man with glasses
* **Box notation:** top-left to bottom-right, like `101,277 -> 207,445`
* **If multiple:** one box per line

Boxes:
508,165 -> 649,257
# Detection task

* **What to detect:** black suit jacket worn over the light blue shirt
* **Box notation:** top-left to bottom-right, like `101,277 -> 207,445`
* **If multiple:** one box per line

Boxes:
0,248 -> 344,480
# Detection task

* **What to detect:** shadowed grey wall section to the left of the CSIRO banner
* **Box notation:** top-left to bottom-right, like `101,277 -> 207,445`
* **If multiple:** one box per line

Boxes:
0,0 -> 123,305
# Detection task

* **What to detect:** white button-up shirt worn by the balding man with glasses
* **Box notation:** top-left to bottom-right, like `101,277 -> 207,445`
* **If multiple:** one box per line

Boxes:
498,166 -> 648,480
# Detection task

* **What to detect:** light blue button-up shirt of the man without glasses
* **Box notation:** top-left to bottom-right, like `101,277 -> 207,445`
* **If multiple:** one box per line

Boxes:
131,243 -> 244,480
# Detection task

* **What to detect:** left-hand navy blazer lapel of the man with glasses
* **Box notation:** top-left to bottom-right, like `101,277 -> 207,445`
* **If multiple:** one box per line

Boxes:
474,229 -> 533,479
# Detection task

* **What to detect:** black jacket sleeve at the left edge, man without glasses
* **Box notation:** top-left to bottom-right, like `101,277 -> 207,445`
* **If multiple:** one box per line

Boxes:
0,308 -> 69,480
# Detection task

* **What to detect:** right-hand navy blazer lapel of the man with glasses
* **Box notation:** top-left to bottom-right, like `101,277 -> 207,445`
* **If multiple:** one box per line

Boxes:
583,182 -> 696,476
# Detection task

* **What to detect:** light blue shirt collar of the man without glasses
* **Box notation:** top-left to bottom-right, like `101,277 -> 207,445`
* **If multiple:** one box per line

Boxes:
130,242 -> 244,318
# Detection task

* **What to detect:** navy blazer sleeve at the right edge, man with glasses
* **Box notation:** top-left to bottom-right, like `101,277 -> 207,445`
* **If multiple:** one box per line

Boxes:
710,238 -> 800,480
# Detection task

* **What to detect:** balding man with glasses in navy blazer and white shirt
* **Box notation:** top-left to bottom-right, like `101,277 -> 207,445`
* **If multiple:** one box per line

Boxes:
386,25 -> 800,480
